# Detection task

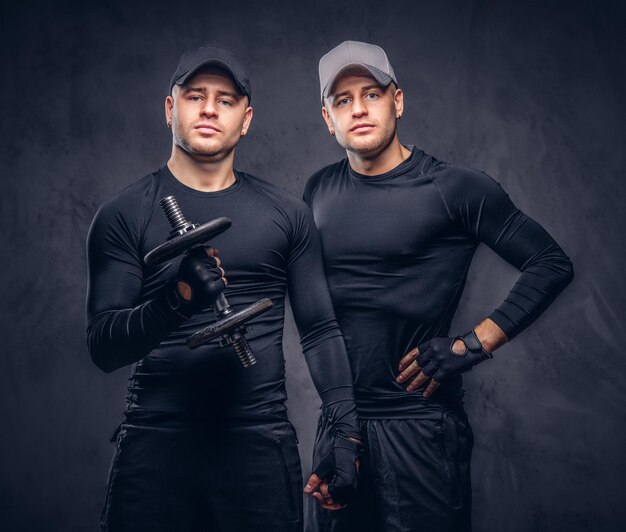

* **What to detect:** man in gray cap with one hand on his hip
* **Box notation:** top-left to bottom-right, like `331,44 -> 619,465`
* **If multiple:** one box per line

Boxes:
304,41 -> 573,532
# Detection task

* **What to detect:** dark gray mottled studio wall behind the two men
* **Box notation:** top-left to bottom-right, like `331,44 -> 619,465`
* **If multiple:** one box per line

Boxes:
0,0 -> 626,532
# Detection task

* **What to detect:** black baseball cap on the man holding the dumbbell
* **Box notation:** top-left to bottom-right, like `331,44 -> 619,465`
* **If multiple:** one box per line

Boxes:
170,46 -> 252,101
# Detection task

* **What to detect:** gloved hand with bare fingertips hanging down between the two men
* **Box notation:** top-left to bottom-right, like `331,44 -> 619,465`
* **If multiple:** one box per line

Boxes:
304,435 -> 362,510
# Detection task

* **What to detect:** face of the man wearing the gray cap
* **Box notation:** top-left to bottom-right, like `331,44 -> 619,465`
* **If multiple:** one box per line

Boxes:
322,75 -> 403,157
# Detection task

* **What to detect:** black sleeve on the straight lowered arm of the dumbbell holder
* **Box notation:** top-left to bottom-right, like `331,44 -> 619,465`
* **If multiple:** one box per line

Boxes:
288,205 -> 360,439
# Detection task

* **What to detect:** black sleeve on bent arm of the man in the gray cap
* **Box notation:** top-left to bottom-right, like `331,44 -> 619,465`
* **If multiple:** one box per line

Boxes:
436,167 -> 574,340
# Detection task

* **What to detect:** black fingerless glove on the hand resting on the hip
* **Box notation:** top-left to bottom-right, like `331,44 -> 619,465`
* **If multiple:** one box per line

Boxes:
417,330 -> 493,382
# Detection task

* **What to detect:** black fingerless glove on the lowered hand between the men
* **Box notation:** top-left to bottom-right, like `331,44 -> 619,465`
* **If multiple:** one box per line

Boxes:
313,434 -> 363,505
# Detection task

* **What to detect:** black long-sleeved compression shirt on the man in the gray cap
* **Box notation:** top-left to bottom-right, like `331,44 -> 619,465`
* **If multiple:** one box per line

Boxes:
304,147 -> 573,417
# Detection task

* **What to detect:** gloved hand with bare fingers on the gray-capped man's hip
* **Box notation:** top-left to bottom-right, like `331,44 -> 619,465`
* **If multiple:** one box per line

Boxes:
396,331 -> 493,397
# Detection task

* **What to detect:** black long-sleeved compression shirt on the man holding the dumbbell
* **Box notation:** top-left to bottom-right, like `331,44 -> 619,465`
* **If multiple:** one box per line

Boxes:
87,166 -> 356,435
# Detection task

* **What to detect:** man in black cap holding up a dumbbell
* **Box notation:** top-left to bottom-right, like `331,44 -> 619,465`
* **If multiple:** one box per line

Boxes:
87,47 -> 360,532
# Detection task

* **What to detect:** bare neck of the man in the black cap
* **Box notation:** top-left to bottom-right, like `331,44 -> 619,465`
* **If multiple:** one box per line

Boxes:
167,144 -> 235,192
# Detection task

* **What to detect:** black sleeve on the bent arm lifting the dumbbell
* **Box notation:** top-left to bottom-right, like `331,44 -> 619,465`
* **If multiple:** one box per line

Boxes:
87,197 -> 185,372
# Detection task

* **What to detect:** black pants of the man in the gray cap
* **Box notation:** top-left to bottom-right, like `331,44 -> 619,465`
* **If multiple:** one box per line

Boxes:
306,412 -> 474,532
